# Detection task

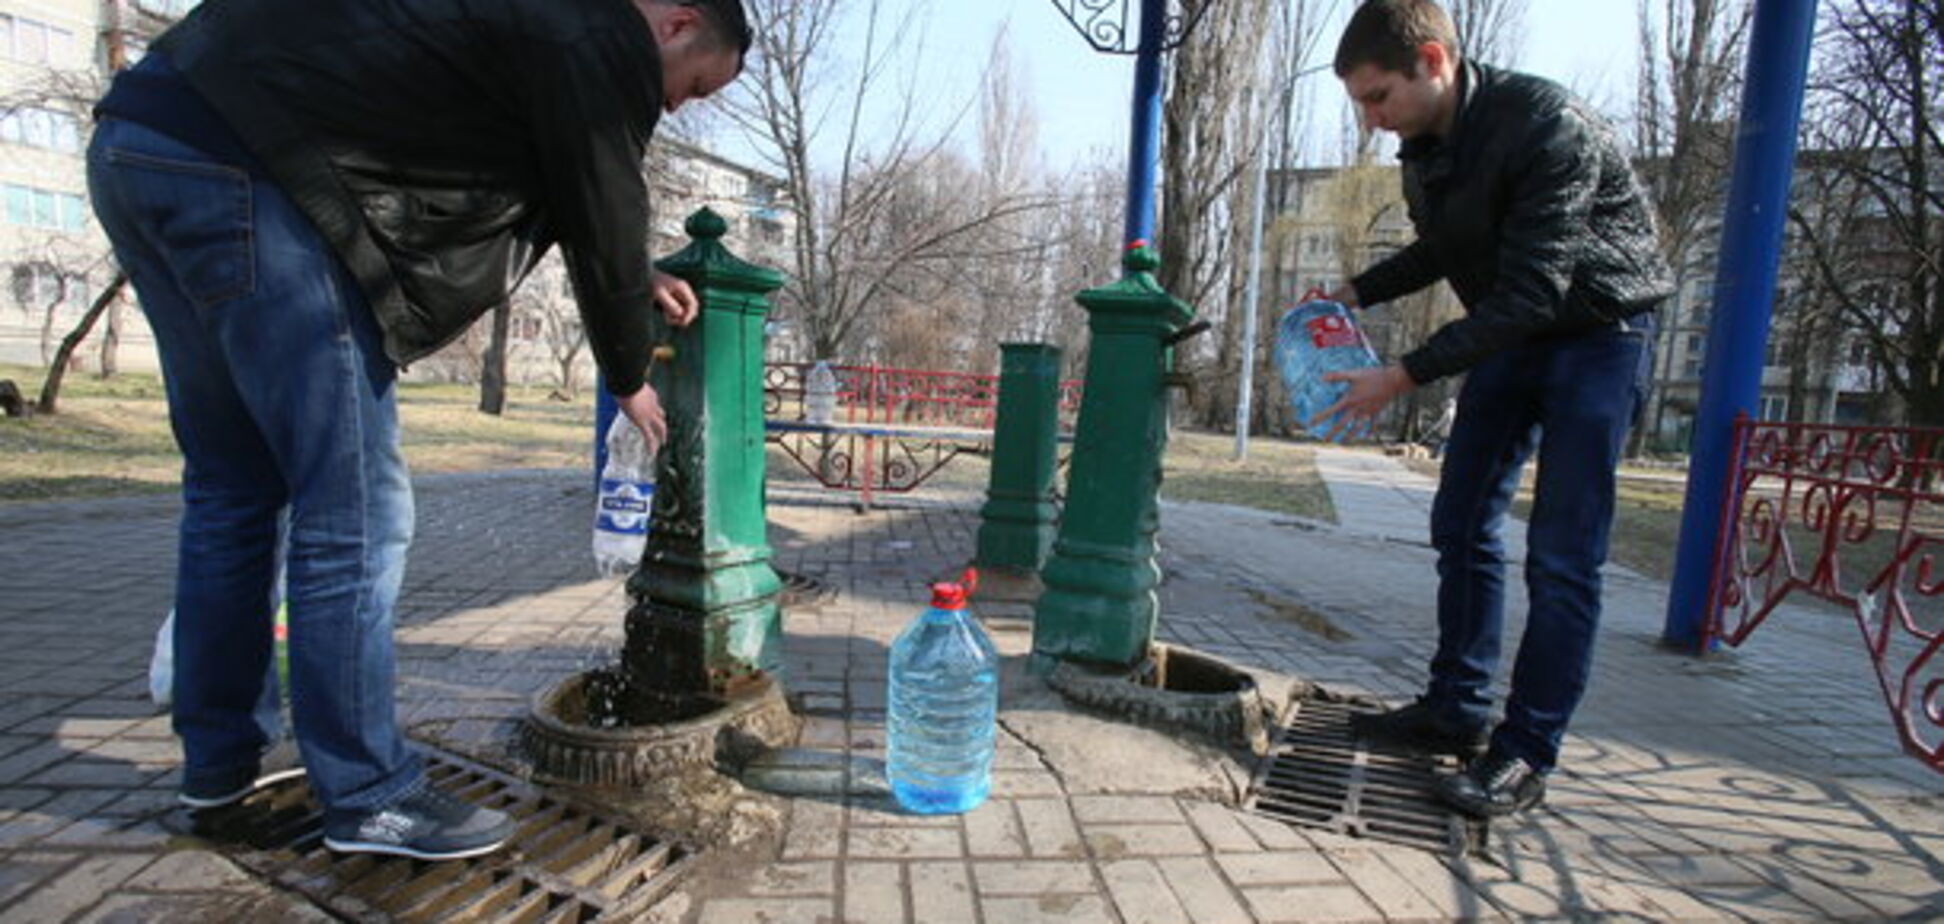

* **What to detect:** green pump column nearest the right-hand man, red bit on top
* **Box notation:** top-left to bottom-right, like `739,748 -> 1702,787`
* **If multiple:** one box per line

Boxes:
1032,245 -> 1194,667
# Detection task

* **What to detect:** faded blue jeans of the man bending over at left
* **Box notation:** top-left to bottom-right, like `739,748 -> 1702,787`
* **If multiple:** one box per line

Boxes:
87,119 -> 422,815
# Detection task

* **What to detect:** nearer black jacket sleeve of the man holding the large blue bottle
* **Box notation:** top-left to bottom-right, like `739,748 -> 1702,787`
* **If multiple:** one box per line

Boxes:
1407,107 -> 1600,383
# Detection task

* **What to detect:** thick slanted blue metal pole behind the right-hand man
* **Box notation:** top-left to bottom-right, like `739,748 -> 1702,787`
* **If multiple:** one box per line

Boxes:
1660,0 -> 1816,650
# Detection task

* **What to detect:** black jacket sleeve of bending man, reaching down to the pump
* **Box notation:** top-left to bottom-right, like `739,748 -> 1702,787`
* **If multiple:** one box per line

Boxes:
527,31 -> 653,395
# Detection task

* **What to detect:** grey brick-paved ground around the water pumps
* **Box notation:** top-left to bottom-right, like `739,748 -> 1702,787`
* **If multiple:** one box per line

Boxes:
0,462 -> 1944,924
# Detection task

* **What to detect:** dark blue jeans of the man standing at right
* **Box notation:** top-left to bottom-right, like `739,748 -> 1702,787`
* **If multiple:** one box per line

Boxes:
1427,315 -> 1652,770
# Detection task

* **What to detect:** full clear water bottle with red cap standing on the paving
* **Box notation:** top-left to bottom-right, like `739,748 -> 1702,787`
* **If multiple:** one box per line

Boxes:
885,570 -> 999,815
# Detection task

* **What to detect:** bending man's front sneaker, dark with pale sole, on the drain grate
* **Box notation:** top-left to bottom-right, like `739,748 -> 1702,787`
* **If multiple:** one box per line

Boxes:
325,784 -> 513,860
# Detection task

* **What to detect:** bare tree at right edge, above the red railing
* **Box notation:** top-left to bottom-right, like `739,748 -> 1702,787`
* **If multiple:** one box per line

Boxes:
1790,0 -> 1944,426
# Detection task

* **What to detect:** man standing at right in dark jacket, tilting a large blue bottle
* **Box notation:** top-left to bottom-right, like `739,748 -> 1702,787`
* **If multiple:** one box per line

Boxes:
1320,0 -> 1672,815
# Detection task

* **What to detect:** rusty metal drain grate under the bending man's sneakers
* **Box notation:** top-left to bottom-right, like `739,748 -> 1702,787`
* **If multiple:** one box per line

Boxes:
175,749 -> 694,924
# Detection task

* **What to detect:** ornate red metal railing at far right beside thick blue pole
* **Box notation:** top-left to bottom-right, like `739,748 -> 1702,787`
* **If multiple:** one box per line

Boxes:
1705,416 -> 1944,770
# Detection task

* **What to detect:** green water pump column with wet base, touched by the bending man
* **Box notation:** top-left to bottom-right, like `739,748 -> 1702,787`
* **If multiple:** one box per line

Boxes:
622,208 -> 783,696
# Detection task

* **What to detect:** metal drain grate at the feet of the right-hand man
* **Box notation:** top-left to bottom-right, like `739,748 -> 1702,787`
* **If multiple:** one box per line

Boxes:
1242,698 -> 1485,854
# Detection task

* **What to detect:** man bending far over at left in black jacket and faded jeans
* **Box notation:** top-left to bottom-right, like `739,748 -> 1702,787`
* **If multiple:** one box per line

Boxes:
87,0 -> 750,860
